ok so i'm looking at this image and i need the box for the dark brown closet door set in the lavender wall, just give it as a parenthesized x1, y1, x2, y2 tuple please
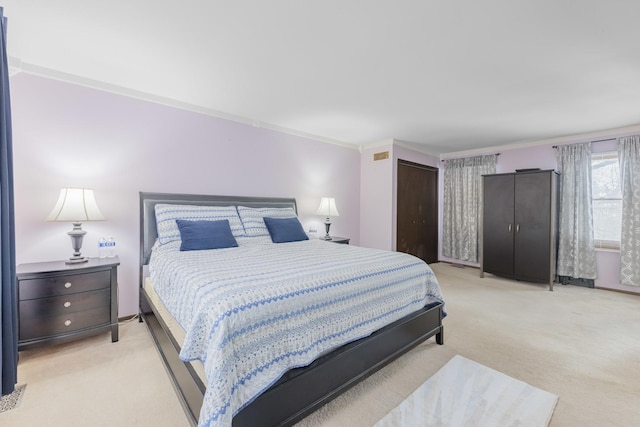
(396, 160, 438, 263)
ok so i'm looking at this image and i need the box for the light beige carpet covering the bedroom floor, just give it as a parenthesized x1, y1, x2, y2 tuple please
(5, 263, 640, 427)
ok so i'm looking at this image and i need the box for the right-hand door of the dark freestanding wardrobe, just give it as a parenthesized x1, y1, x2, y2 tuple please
(514, 171, 553, 282)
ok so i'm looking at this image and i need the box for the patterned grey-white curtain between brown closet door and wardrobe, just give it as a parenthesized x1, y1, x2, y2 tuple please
(442, 154, 497, 262)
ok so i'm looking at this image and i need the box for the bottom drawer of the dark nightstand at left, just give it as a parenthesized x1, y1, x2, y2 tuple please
(20, 306, 110, 341)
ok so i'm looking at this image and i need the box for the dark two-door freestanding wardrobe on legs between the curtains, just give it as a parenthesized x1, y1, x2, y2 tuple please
(481, 170, 558, 290)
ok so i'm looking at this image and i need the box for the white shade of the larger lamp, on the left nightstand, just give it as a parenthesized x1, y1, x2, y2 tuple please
(47, 188, 105, 222)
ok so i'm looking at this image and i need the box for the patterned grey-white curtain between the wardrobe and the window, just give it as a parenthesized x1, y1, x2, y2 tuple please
(557, 142, 596, 279)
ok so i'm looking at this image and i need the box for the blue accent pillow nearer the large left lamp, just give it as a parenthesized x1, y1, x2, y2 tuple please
(176, 219, 238, 251)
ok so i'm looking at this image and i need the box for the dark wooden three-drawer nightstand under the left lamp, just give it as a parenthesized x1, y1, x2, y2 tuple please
(16, 257, 120, 350)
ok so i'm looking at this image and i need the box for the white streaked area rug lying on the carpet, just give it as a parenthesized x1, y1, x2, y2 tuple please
(376, 355, 558, 427)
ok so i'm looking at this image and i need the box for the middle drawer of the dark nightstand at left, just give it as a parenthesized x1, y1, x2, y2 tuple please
(20, 288, 111, 320)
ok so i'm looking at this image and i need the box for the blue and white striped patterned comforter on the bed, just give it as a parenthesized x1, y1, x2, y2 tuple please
(149, 237, 442, 426)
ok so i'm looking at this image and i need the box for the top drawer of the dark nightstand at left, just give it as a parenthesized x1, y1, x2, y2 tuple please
(20, 271, 111, 301)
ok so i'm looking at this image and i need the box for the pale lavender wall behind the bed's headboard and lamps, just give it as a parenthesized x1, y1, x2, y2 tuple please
(11, 74, 360, 316)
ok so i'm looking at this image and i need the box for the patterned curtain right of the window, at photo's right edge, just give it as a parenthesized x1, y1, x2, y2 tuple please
(618, 135, 640, 286)
